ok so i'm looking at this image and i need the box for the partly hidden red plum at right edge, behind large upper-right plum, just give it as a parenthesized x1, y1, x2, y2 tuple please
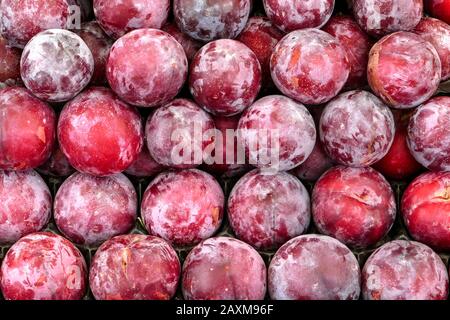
(414, 16, 450, 81)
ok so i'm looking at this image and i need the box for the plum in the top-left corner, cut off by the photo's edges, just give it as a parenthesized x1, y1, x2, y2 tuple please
(0, 0, 70, 48)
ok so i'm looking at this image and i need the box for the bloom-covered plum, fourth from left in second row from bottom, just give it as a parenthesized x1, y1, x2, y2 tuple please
(228, 170, 311, 250)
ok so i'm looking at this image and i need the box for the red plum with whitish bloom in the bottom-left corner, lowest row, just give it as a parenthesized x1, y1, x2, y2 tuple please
(0, 232, 87, 300)
